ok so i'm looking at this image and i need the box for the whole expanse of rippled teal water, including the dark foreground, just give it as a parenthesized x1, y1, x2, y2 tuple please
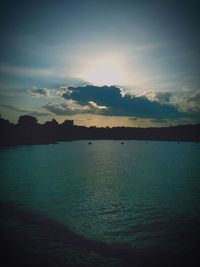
(0, 140, 200, 267)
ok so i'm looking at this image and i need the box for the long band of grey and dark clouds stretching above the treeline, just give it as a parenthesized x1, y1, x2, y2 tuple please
(1, 85, 200, 123)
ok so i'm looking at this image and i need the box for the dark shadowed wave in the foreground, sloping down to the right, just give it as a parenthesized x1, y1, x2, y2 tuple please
(0, 203, 198, 267)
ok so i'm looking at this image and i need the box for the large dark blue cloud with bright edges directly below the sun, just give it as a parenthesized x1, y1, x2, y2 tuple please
(61, 85, 185, 119)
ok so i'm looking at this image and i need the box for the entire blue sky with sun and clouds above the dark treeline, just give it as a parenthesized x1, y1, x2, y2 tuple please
(0, 0, 200, 127)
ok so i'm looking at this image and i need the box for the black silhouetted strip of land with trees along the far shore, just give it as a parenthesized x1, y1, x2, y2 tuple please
(0, 115, 200, 147)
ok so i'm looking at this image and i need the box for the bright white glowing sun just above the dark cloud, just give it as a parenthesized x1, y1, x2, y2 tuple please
(79, 57, 123, 86)
